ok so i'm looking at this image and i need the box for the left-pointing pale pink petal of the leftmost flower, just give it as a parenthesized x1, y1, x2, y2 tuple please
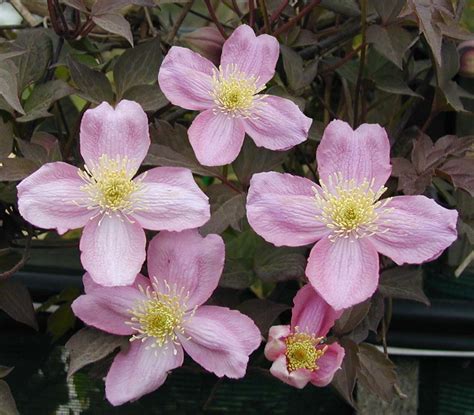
(17, 162, 95, 234)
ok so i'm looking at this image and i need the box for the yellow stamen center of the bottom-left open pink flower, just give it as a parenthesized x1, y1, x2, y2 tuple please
(126, 283, 194, 348)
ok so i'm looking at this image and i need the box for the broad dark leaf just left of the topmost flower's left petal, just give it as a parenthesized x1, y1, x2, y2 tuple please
(114, 38, 163, 100)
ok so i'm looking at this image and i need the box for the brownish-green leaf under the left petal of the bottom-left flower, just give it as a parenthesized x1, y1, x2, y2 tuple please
(65, 327, 128, 379)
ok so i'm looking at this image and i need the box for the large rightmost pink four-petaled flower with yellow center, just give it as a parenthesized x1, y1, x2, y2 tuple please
(247, 120, 458, 309)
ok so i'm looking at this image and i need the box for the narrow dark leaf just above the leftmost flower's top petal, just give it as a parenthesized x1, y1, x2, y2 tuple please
(67, 57, 114, 104)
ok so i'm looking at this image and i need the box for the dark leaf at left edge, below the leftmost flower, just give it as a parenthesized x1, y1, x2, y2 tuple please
(0, 280, 38, 330)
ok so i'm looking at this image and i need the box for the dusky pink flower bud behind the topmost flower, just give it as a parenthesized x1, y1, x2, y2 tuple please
(181, 26, 225, 65)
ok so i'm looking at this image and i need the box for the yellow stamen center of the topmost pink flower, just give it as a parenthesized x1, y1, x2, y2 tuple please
(210, 64, 265, 118)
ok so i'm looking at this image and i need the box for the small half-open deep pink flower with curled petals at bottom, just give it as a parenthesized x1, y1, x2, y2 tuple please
(265, 285, 345, 389)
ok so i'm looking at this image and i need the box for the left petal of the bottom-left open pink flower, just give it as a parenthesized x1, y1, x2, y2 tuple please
(71, 287, 146, 335)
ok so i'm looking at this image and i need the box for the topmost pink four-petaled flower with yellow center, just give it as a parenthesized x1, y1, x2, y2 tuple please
(158, 25, 312, 166)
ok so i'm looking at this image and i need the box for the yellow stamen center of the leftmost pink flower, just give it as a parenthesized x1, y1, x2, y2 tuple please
(79, 154, 141, 213)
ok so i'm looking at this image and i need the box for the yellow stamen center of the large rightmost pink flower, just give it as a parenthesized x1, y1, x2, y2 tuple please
(313, 173, 390, 241)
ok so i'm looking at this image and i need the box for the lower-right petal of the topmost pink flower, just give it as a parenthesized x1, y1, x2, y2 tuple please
(243, 96, 313, 150)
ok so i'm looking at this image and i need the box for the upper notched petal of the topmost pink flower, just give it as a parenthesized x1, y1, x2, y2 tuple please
(221, 25, 280, 86)
